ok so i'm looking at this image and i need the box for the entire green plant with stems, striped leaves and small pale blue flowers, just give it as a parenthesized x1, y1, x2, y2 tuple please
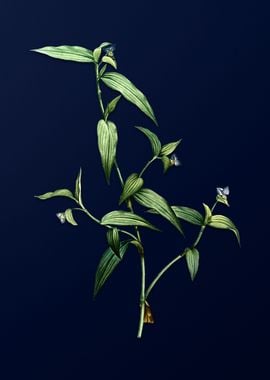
(33, 42, 240, 338)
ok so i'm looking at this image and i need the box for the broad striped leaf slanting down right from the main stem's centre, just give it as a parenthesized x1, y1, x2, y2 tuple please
(134, 189, 183, 233)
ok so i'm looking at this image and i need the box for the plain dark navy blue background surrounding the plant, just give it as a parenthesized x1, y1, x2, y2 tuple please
(0, 0, 269, 380)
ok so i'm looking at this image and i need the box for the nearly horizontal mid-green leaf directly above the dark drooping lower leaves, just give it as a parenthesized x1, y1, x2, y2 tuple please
(100, 210, 159, 231)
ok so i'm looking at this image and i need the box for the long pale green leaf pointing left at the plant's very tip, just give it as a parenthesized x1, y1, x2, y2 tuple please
(31, 45, 94, 63)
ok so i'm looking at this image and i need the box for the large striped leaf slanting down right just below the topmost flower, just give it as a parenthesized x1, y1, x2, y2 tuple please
(101, 72, 157, 125)
